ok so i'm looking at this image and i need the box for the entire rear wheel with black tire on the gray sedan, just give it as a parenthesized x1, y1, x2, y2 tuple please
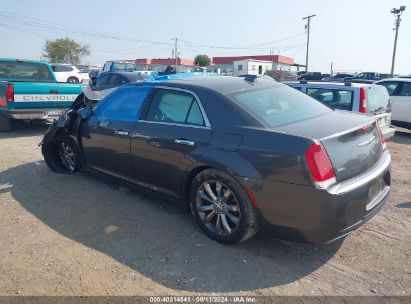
(190, 169, 259, 244)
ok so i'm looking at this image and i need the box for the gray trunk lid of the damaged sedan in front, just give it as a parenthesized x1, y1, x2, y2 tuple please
(275, 111, 383, 182)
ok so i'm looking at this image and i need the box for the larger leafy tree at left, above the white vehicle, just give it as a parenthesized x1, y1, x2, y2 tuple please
(43, 37, 90, 64)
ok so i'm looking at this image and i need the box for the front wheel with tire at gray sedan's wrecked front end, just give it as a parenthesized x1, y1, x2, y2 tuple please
(42, 134, 82, 174)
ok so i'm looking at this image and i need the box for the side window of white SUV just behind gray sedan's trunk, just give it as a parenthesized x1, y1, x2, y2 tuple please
(307, 88, 353, 111)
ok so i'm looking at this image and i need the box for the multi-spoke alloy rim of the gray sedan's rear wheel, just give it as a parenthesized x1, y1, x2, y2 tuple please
(196, 180, 241, 236)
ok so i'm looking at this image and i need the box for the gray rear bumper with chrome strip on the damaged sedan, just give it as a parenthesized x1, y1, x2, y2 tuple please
(248, 151, 391, 244)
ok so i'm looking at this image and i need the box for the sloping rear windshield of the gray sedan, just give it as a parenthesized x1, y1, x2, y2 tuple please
(228, 86, 332, 128)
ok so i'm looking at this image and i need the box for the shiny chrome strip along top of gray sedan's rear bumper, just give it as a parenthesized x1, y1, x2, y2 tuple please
(327, 151, 391, 195)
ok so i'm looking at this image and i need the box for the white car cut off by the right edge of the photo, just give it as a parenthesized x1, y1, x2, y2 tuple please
(376, 78, 411, 130)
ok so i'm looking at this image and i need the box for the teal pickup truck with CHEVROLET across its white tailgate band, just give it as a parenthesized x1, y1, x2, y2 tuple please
(0, 58, 82, 131)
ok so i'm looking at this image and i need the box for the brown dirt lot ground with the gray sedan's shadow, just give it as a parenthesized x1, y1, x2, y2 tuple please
(0, 121, 411, 295)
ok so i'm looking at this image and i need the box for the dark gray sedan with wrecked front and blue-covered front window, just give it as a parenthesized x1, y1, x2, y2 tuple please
(42, 75, 391, 243)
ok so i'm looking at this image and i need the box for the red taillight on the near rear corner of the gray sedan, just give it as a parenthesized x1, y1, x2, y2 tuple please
(305, 142, 336, 189)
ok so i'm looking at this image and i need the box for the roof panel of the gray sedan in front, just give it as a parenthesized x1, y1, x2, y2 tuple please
(135, 74, 282, 94)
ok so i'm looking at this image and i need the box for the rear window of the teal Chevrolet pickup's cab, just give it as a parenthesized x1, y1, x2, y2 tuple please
(0, 61, 54, 81)
